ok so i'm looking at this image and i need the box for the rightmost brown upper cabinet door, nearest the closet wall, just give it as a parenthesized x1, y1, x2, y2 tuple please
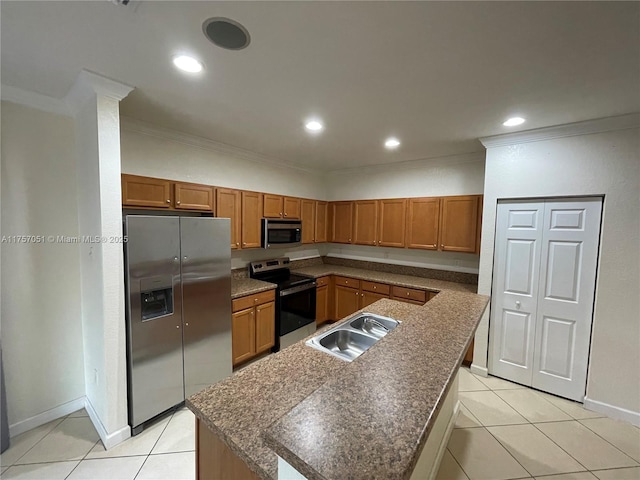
(440, 195, 480, 253)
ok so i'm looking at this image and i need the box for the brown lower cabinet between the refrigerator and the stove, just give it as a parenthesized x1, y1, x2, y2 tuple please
(231, 290, 276, 367)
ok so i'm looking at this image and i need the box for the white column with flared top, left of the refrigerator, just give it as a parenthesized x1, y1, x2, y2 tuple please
(66, 70, 132, 448)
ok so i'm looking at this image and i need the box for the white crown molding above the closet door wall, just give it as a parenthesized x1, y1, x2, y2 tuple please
(479, 113, 640, 148)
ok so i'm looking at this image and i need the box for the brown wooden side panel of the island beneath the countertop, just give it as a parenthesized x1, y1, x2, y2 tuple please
(196, 418, 260, 480)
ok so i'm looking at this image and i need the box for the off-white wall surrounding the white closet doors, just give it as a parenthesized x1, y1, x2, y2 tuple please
(474, 129, 640, 423)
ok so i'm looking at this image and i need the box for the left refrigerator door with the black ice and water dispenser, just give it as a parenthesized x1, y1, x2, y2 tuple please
(125, 216, 184, 430)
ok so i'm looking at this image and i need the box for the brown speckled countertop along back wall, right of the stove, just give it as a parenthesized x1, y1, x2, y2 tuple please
(292, 264, 478, 293)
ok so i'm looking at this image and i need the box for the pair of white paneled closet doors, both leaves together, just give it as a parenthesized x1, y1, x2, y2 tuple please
(489, 198, 602, 401)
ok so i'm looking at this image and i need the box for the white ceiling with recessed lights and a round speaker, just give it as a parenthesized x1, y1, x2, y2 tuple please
(1, 0, 640, 170)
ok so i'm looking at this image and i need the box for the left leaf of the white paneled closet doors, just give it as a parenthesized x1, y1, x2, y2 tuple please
(489, 202, 544, 385)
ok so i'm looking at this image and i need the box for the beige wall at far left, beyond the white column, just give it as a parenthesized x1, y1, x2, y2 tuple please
(1, 102, 85, 430)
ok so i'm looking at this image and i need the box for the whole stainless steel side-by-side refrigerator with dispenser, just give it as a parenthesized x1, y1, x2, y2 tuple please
(124, 215, 231, 435)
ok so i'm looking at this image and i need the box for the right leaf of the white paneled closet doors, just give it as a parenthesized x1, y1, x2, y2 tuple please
(532, 198, 602, 402)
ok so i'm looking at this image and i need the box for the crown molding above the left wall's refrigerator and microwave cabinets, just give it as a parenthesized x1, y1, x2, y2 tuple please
(120, 115, 320, 175)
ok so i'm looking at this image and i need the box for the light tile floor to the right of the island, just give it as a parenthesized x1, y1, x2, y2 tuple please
(437, 368, 640, 480)
